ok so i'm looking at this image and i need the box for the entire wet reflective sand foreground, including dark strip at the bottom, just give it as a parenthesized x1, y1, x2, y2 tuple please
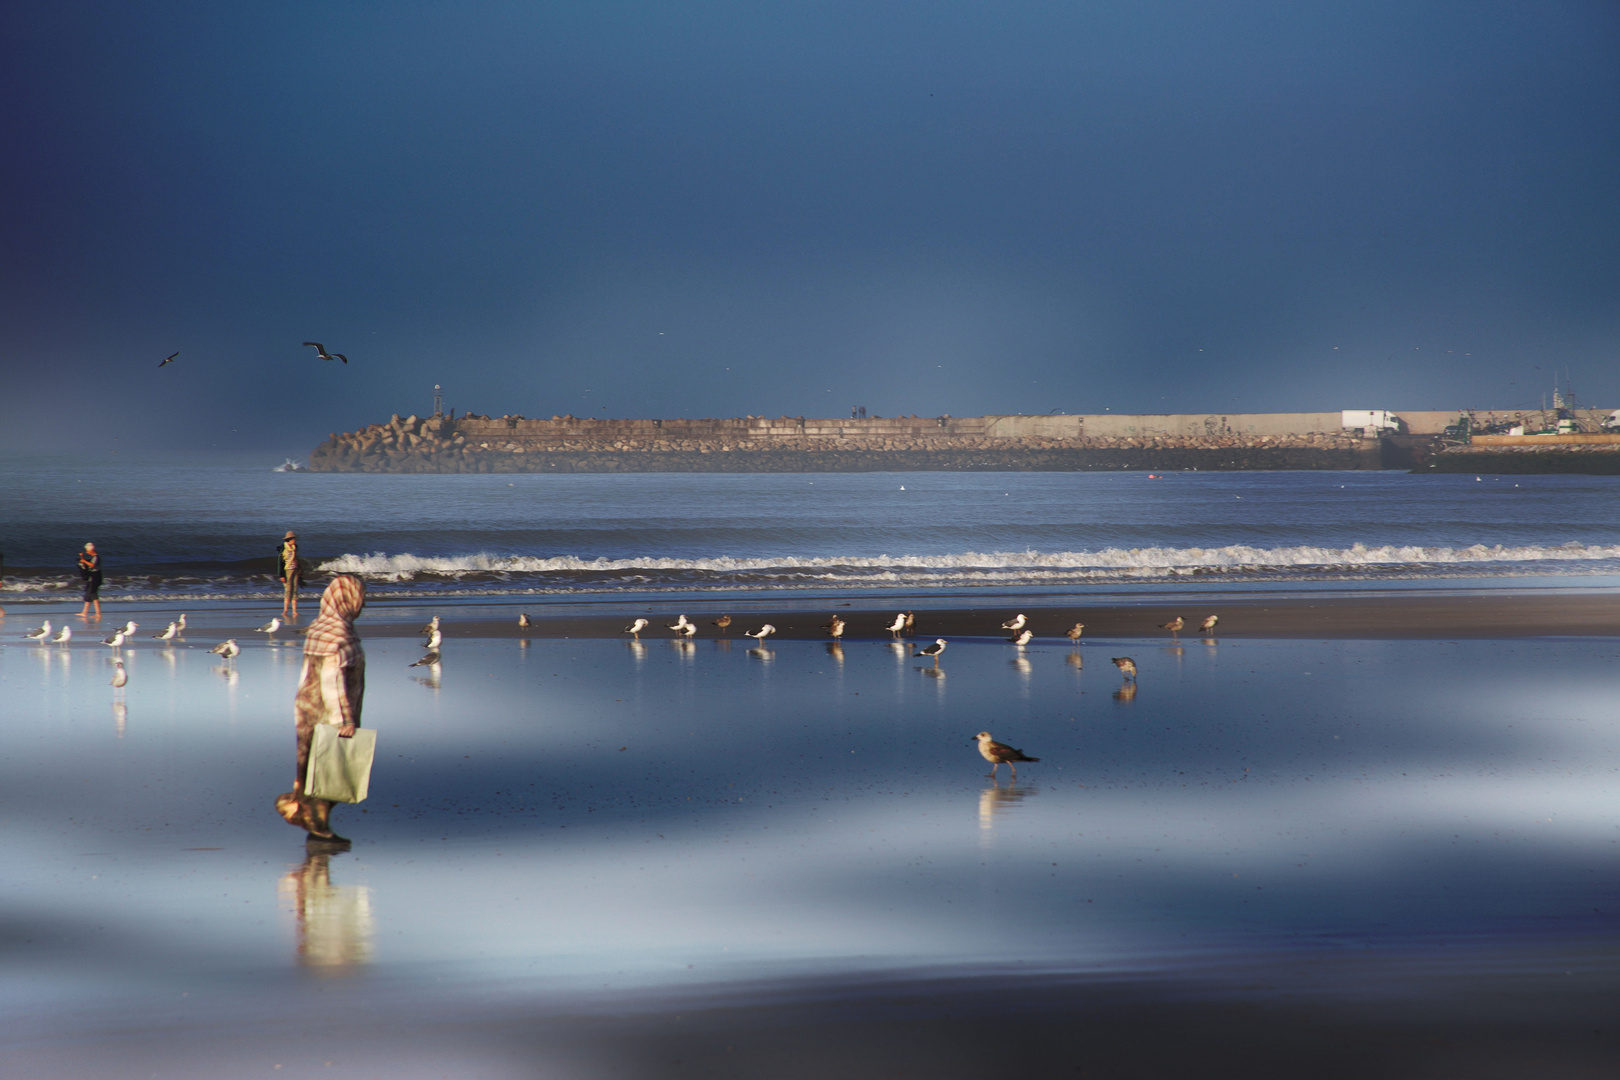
(0, 614, 1620, 1077)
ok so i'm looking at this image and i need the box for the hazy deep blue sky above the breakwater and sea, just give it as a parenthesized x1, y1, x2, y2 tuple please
(0, 0, 1620, 453)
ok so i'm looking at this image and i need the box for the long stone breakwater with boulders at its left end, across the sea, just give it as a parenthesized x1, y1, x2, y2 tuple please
(309, 415, 1411, 473)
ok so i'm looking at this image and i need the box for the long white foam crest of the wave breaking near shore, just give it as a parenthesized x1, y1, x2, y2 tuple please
(319, 544, 1620, 581)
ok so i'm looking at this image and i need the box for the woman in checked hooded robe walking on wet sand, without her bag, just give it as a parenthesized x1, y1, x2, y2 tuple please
(275, 573, 366, 840)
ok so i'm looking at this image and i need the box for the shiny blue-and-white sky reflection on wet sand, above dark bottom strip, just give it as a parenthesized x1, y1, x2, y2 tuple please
(0, 640, 1620, 1016)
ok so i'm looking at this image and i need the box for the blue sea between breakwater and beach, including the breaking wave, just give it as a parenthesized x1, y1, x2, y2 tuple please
(0, 458, 1620, 604)
